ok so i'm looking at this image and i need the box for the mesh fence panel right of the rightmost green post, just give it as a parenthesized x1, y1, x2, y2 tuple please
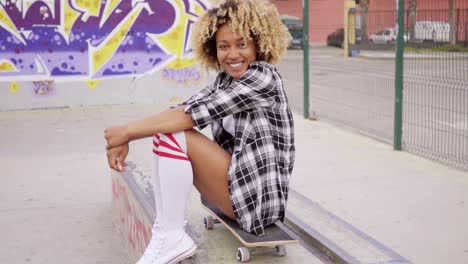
(402, 8, 468, 169)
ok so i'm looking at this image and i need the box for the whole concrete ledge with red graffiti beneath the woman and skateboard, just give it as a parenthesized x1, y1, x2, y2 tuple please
(111, 142, 410, 264)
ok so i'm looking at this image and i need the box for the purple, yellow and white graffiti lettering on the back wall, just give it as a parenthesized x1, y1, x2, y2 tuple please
(0, 0, 212, 81)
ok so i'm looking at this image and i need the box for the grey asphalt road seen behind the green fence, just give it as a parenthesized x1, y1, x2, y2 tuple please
(278, 47, 468, 168)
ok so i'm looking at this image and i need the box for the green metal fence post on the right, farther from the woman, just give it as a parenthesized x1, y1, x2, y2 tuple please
(393, 0, 405, 150)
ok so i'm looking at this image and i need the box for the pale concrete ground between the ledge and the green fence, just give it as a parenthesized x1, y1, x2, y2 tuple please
(292, 116, 468, 264)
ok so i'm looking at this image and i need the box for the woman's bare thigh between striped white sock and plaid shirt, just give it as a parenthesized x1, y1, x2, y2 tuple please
(185, 129, 235, 219)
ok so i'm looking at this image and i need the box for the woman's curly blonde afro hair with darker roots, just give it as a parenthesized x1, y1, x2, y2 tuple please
(192, 0, 291, 70)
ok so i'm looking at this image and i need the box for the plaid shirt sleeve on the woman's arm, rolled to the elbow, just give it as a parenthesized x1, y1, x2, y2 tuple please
(185, 62, 277, 129)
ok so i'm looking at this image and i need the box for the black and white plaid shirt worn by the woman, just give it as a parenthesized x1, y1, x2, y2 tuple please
(183, 62, 295, 236)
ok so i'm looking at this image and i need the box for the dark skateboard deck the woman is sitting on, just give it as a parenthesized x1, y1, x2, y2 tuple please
(201, 196, 298, 247)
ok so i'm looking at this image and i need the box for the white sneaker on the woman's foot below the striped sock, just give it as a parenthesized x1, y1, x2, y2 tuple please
(136, 228, 197, 264)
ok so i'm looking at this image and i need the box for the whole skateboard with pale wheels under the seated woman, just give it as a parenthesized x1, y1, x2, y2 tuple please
(201, 196, 298, 262)
